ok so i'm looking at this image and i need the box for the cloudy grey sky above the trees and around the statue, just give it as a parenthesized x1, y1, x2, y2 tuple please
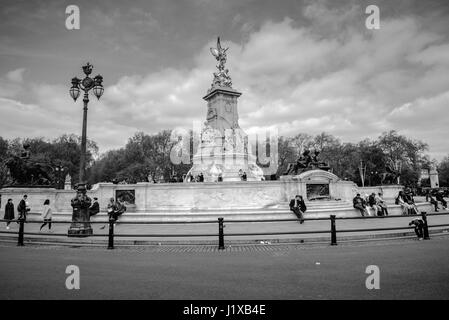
(0, 0, 449, 159)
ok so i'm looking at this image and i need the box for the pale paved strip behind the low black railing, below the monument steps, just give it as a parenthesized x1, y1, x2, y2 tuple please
(0, 214, 449, 243)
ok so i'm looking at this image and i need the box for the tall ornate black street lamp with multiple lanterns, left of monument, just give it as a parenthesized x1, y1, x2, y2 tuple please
(68, 63, 104, 237)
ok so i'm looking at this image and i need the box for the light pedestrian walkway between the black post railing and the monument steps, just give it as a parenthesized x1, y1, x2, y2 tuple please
(0, 214, 449, 246)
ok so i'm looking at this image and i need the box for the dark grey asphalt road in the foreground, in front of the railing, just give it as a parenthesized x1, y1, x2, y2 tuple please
(0, 236, 449, 300)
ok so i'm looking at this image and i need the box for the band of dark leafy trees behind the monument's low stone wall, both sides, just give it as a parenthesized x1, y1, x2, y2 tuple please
(0, 130, 442, 187)
